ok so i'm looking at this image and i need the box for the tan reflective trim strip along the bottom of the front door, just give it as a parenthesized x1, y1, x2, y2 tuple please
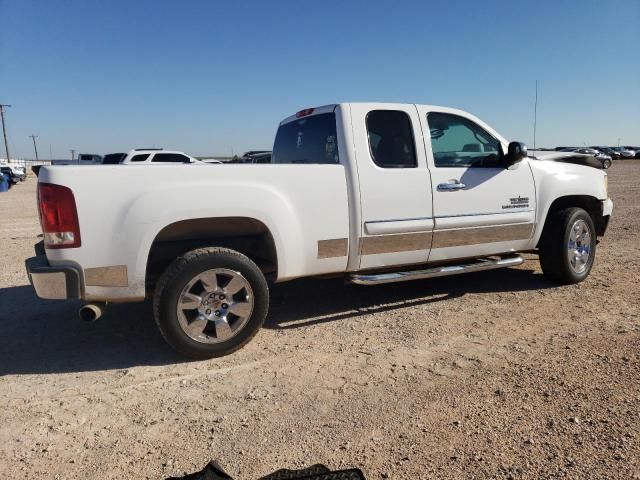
(431, 223, 535, 248)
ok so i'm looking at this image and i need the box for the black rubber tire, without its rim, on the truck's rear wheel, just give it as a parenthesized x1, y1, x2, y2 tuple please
(153, 247, 269, 359)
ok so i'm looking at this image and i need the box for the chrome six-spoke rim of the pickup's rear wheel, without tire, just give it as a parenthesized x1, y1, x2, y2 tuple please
(177, 268, 253, 343)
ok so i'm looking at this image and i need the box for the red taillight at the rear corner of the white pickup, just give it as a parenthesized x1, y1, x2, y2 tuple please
(38, 183, 80, 248)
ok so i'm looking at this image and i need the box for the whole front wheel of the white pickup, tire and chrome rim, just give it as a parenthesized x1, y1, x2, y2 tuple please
(539, 208, 596, 284)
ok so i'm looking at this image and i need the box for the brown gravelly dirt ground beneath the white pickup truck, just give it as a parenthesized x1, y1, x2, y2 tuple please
(0, 161, 640, 479)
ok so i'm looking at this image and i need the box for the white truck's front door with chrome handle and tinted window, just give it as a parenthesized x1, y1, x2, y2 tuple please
(421, 107, 536, 261)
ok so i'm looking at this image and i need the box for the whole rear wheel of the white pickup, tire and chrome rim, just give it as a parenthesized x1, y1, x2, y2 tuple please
(153, 247, 269, 359)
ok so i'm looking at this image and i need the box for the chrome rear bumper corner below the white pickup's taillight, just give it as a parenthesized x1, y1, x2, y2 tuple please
(25, 255, 81, 300)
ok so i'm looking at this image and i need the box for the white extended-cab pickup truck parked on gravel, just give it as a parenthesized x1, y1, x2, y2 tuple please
(27, 103, 613, 358)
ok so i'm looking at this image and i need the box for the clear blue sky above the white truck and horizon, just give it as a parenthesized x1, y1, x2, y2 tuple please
(0, 0, 640, 158)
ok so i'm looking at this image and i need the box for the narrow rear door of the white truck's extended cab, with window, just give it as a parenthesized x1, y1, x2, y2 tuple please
(351, 104, 433, 269)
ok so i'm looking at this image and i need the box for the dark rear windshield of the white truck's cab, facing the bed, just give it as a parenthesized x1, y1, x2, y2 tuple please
(271, 112, 340, 163)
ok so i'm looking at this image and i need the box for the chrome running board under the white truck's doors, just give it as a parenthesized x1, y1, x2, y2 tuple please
(350, 255, 524, 285)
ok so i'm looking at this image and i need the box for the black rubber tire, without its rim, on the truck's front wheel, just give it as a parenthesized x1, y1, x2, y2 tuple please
(539, 207, 596, 284)
